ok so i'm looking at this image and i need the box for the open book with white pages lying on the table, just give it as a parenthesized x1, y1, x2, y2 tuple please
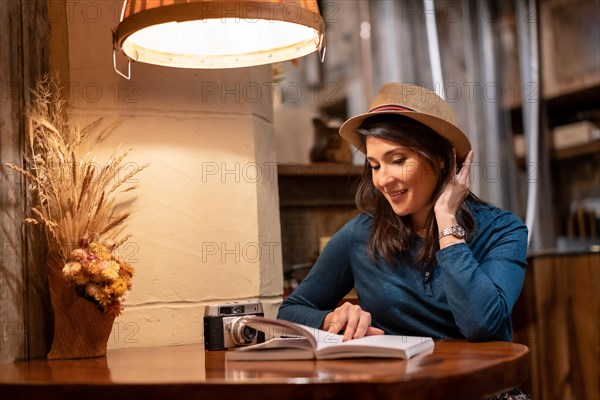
(226, 316, 434, 360)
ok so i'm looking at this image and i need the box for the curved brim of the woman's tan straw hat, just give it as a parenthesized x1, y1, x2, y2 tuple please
(339, 111, 471, 164)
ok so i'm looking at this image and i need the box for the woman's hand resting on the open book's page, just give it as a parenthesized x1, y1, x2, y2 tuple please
(321, 302, 384, 341)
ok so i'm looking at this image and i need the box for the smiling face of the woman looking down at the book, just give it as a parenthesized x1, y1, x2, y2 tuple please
(366, 136, 439, 227)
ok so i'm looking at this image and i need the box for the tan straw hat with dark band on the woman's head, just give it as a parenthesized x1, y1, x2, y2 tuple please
(340, 82, 471, 163)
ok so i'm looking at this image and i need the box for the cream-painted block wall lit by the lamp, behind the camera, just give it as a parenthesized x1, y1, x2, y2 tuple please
(58, 1, 283, 348)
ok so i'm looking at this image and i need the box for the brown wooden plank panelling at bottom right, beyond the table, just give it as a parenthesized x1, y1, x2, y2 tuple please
(514, 253, 600, 400)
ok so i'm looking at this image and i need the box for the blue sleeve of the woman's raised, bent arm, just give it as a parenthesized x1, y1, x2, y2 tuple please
(436, 212, 527, 341)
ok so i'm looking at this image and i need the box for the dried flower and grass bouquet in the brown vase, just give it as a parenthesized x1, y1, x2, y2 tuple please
(5, 76, 147, 316)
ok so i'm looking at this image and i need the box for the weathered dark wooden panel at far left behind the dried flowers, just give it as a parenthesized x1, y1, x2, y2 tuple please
(0, 0, 49, 362)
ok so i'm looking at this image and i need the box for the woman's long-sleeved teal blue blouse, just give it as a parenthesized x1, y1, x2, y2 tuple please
(278, 202, 527, 341)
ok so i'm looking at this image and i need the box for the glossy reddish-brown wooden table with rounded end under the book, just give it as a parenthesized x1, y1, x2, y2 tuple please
(0, 340, 529, 400)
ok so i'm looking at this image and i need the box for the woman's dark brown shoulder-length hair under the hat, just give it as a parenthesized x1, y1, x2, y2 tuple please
(356, 114, 483, 269)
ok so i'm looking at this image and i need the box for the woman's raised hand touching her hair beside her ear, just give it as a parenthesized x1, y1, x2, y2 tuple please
(433, 151, 473, 222)
